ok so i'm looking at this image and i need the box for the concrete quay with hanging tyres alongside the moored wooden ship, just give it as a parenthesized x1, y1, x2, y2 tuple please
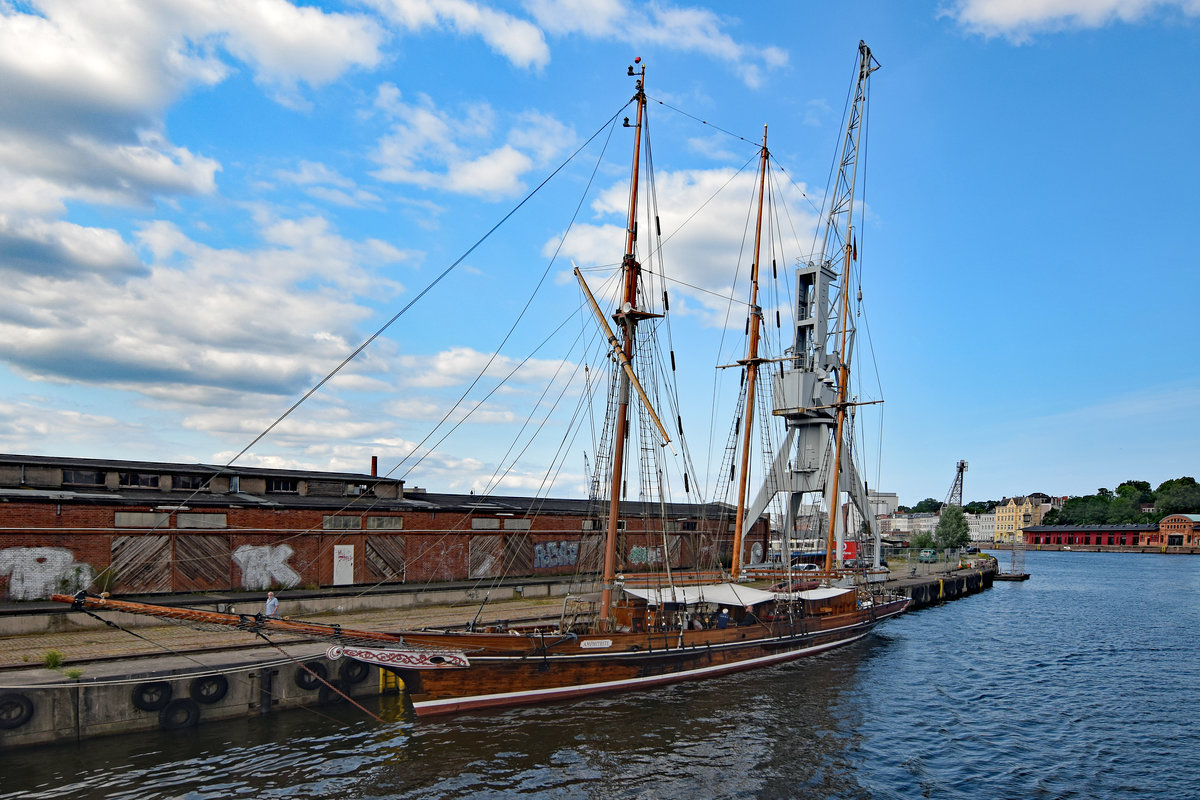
(0, 565, 994, 751)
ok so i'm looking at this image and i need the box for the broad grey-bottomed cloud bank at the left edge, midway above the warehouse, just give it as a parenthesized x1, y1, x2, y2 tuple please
(0, 217, 408, 403)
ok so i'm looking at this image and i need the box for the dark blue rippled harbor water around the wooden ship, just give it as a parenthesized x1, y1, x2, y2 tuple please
(0, 552, 1200, 800)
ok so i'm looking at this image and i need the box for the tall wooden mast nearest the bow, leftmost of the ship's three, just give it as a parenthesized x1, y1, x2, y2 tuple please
(599, 64, 646, 630)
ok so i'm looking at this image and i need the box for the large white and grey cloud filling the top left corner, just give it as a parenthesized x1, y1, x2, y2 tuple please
(0, 0, 385, 213)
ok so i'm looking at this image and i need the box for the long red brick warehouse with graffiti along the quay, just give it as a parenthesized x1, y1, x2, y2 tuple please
(0, 455, 768, 600)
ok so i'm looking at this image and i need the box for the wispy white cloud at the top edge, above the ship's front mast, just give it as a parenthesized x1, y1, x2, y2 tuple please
(526, 0, 787, 88)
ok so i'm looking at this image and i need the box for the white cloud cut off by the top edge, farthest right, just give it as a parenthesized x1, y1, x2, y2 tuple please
(944, 0, 1200, 42)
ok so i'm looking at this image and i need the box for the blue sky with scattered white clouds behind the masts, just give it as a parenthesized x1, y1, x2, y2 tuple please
(0, 0, 1200, 504)
